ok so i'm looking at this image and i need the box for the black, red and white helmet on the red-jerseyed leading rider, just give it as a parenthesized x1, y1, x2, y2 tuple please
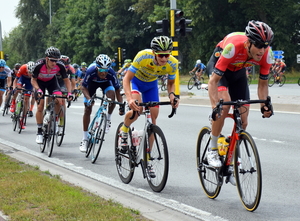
(245, 20, 274, 45)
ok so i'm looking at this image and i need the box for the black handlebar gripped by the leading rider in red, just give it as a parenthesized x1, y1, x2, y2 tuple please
(211, 96, 274, 121)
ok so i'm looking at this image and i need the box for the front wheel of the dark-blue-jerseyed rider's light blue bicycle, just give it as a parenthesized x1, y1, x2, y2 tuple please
(90, 113, 107, 163)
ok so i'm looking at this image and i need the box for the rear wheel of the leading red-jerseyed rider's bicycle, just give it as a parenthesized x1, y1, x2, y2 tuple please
(196, 127, 223, 199)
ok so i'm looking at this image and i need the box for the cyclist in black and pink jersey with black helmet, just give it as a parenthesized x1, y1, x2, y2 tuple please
(31, 46, 73, 144)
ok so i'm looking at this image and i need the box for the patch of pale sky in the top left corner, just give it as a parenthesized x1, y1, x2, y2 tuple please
(0, 0, 19, 37)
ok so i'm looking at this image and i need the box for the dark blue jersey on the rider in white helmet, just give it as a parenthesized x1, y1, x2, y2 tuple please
(82, 63, 120, 89)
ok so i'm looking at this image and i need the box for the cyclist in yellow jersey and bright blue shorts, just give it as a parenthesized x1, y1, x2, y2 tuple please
(120, 36, 179, 177)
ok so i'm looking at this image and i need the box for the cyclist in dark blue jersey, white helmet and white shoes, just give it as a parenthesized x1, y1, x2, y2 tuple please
(79, 54, 124, 152)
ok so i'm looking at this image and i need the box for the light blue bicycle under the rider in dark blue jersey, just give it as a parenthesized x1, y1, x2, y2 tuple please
(85, 94, 124, 163)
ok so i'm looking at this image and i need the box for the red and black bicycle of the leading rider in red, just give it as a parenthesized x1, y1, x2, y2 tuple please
(196, 97, 273, 212)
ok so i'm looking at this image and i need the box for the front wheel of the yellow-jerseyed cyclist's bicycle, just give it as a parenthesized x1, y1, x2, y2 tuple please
(144, 125, 169, 192)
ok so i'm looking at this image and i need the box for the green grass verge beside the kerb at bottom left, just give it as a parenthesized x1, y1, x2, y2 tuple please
(0, 153, 148, 221)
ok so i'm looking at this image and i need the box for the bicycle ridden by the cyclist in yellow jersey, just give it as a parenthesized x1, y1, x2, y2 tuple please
(115, 99, 176, 192)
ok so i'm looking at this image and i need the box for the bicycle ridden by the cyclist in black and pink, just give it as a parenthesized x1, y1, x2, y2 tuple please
(38, 94, 67, 157)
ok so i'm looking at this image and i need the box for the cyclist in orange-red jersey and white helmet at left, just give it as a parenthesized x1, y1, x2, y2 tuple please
(10, 61, 35, 129)
